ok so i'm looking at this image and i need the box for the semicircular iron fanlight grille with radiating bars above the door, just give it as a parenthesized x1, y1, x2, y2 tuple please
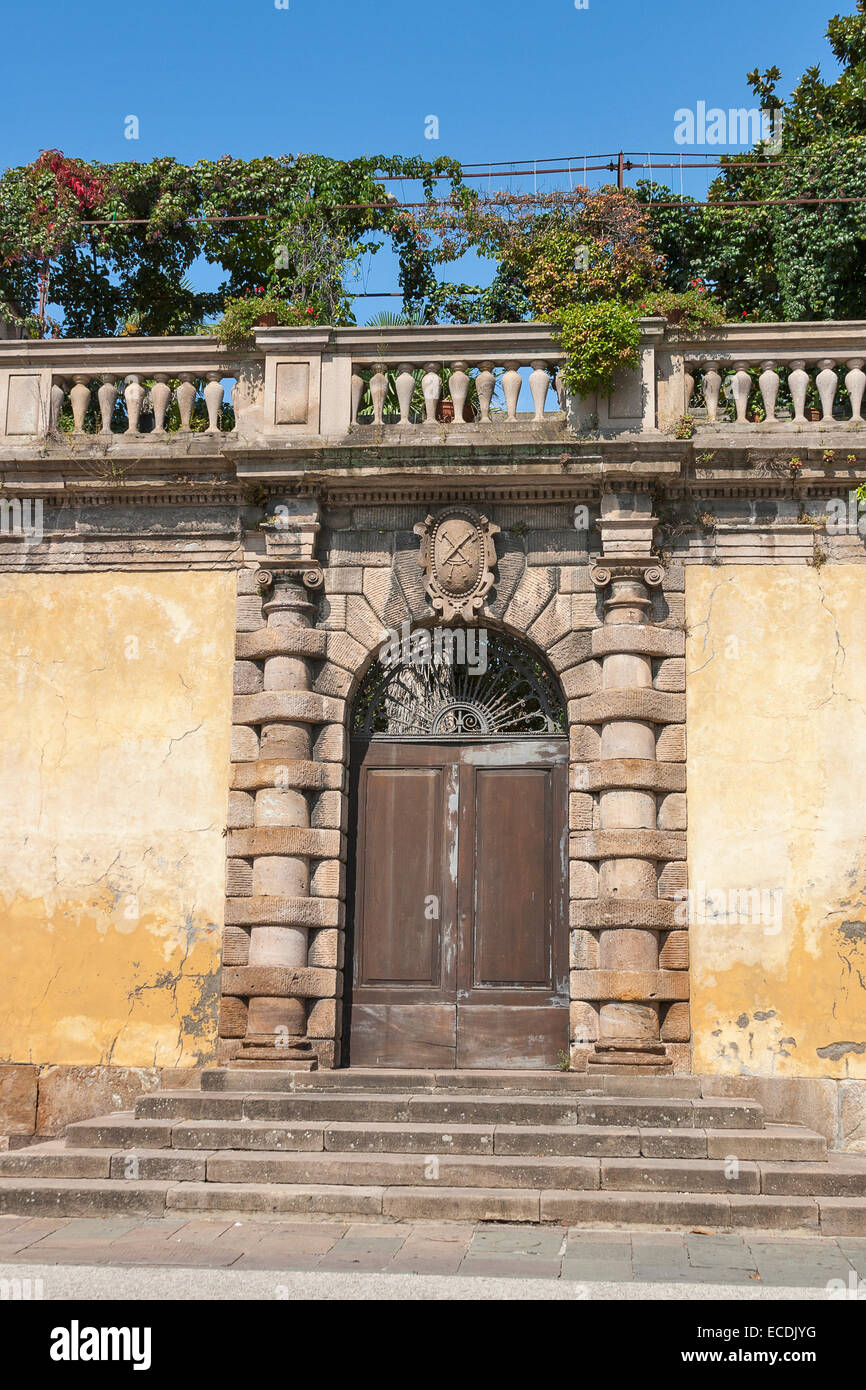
(352, 630, 567, 739)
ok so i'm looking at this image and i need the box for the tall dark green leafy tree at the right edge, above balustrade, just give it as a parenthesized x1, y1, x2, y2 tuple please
(638, 0, 866, 321)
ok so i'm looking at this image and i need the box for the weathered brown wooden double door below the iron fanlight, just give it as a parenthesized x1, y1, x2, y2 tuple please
(346, 737, 569, 1069)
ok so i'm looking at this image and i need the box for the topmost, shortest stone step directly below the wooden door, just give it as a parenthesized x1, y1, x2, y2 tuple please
(202, 1068, 706, 1099)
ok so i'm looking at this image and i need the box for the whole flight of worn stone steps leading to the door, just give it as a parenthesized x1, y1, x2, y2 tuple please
(0, 1069, 866, 1236)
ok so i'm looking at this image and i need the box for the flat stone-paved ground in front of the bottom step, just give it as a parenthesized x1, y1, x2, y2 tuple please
(0, 1216, 866, 1301)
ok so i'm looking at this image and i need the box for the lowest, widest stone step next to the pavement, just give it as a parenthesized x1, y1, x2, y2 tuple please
(0, 1177, 866, 1237)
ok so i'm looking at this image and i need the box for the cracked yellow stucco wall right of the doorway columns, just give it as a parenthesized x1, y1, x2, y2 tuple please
(685, 566, 866, 1077)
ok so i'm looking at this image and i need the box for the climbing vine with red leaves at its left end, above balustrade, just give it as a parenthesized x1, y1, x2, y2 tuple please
(0, 150, 471, 336)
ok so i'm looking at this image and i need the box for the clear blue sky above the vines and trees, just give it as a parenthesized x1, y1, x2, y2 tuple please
(0, 0, 855, 317)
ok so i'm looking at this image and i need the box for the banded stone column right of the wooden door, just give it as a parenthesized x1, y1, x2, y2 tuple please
(578, 495, 688, 1072)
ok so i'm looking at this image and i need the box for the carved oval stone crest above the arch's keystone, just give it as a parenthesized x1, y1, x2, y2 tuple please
(414, 507, 499, 623)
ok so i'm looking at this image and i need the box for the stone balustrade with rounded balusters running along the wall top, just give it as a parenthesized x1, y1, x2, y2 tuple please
(0, 318, 866, 452)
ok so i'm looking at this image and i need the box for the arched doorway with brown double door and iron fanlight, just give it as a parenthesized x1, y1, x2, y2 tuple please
(345, 628, 569, 1069)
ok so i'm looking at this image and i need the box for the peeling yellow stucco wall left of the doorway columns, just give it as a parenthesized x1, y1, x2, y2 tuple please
(0, 573, 235, 1066)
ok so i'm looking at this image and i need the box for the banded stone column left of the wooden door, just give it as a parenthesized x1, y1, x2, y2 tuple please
(222, 499, 341, 1069)
